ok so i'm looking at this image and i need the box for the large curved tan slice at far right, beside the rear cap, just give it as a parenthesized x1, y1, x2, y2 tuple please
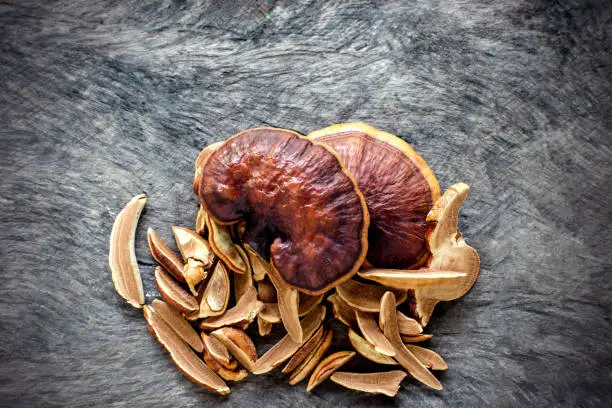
(414, 183, 480, 326)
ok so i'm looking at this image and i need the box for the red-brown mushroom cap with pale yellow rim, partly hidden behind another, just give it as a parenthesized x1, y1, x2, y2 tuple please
(308, 123, 440, 269)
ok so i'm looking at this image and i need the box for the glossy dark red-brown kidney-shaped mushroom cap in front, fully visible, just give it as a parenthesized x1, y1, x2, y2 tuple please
(199, 128, 369, 294)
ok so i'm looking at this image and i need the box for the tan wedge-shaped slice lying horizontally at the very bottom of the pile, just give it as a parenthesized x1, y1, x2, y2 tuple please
(331, 370, 406, 397)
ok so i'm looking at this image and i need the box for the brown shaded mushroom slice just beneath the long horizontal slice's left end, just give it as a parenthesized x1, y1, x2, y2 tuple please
(336, 279, 408, 313)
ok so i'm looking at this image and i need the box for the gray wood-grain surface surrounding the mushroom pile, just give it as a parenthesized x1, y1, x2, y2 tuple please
(0, 0, 612, 407)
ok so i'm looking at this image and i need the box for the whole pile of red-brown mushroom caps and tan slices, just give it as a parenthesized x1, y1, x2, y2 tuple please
(109, 124, 480, 396)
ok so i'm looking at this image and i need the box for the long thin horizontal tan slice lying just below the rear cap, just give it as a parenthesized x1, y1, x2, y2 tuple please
(359, 269, 467, 289)
